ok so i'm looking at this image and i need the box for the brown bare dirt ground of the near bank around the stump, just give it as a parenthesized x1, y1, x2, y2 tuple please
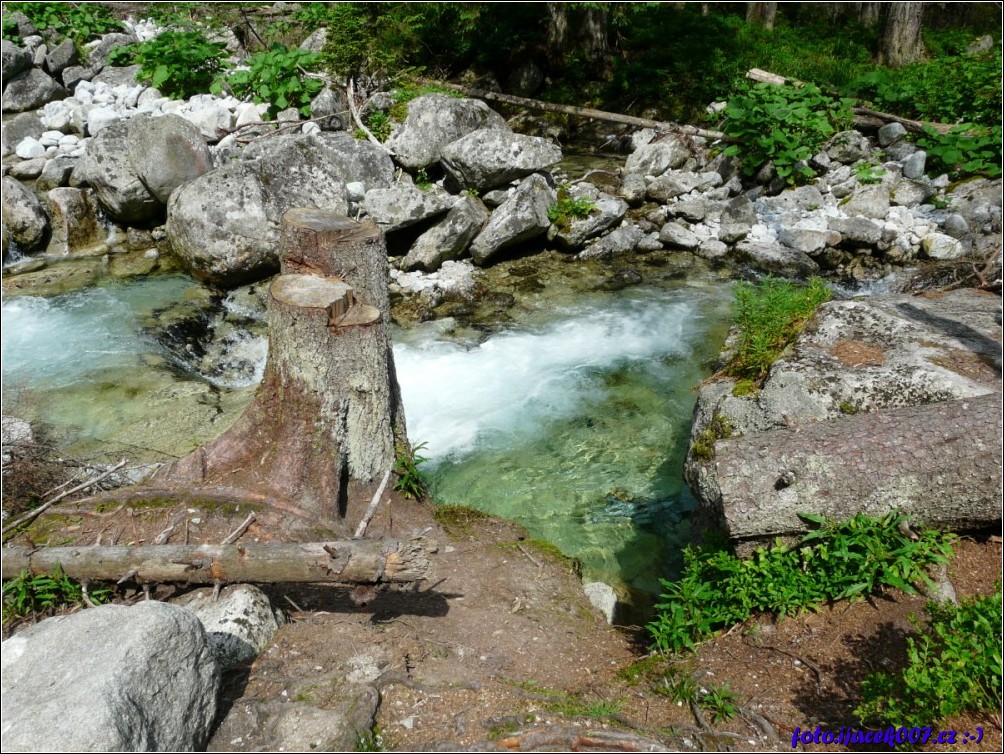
(7, 485, 1002, 751)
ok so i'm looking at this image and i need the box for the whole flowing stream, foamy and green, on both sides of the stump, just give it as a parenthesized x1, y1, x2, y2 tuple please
(2, 269, 729, 614)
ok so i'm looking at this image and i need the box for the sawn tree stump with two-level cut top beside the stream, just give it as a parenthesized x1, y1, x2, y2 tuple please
(155, 210, 407, 531)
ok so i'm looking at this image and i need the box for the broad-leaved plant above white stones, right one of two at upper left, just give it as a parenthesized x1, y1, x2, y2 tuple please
(212, 46, 324, 118)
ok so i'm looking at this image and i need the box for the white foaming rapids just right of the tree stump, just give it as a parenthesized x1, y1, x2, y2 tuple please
(395, 293, 697, 460)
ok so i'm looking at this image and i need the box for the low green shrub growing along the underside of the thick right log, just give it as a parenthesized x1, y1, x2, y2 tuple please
(648, 513, 952, 653)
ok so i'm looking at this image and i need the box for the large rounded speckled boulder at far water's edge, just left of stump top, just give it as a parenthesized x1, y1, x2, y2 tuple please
(167, 162, 279, 288)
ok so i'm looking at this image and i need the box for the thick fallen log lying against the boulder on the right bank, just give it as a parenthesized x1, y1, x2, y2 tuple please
(712, 393, 1002, 540)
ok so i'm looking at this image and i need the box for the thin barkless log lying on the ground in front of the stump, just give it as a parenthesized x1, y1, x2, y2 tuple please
(2, 539, 429, 583)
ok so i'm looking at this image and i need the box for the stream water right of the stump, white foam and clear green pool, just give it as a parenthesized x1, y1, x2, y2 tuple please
(396, 287, 728, 592)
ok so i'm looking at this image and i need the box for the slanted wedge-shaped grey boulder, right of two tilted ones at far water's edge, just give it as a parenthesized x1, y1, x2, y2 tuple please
(471, 175, 557, 265)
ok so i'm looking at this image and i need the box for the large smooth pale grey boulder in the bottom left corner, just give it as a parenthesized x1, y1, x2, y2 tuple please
(0, 601, 220, 751)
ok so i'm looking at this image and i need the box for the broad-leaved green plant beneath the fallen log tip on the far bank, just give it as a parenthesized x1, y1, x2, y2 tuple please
(723, 83, 851, 185)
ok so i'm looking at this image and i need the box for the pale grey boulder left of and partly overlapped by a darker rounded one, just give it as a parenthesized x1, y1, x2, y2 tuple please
(77, 120, 164, 225)
